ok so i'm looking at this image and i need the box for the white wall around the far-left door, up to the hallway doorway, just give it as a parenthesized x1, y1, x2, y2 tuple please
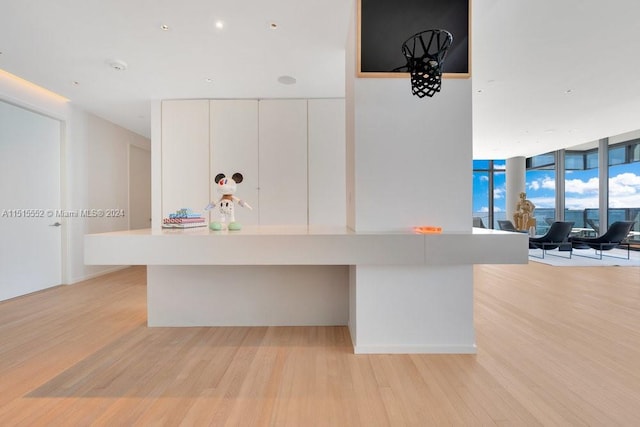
(0, 72, 150, 283)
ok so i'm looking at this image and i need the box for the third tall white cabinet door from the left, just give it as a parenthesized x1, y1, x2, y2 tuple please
(259, 100, 308, 225)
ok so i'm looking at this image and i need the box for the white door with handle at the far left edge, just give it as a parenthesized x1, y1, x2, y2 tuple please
(0, 102, 63, 300)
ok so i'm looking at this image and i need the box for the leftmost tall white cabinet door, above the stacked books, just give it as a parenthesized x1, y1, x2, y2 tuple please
(162, 100, 210, 218)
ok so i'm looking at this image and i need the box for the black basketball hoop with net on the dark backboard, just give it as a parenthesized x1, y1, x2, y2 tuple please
(394, 29, 453, 98)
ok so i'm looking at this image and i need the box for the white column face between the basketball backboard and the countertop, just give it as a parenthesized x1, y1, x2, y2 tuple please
(348, 78, 472, 231)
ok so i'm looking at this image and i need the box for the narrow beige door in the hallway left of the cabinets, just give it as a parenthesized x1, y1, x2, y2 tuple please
(129, 145, 151, 230)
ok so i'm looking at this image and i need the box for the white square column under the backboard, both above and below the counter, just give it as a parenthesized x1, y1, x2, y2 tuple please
(346, 4, 475, 353)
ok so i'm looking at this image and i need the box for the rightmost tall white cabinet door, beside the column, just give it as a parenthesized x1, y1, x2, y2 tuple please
(308, 99, 347, 226)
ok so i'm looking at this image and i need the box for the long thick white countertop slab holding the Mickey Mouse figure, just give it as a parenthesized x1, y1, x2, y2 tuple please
(85, 226, 528, 265)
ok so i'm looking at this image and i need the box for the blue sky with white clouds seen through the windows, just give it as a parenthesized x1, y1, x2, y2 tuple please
(473, 162, 640, 216)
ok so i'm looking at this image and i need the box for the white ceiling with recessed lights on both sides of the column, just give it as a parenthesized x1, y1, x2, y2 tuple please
(0, 0, 640, 159)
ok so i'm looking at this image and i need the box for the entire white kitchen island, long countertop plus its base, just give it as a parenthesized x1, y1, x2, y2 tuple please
(85, 226, 527, 353)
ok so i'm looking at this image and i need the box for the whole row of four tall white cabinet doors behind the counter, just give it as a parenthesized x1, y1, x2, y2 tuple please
(161, 99, 346, 226)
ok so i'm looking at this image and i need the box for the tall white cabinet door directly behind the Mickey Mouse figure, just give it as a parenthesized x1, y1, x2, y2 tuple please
(210, 100, 260, 225)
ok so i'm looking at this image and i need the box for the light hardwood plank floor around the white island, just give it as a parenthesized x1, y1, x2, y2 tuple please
(0, 263, 640, 426)
